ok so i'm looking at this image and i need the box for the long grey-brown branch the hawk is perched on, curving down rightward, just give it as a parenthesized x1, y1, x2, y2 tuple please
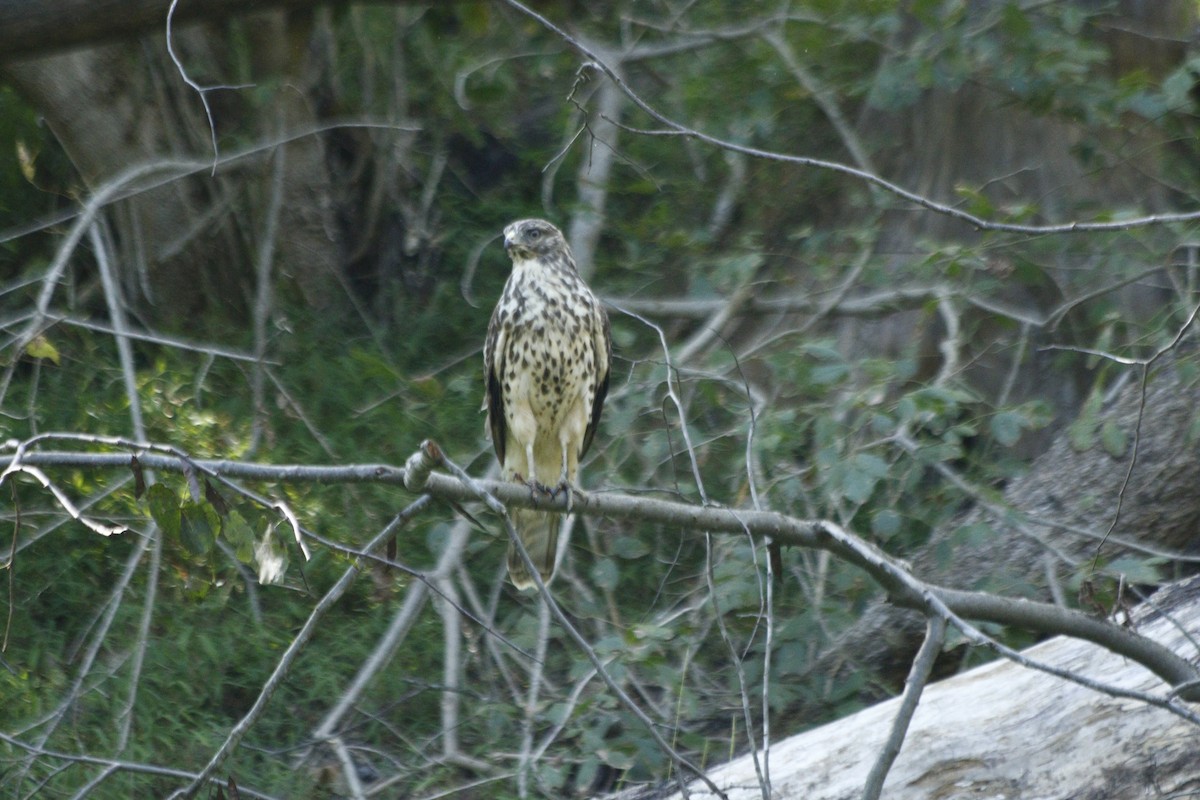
(9, 443, 1200, 700)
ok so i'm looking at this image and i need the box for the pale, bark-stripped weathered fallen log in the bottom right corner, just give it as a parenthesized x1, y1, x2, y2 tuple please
(623, 579, 1200, 800)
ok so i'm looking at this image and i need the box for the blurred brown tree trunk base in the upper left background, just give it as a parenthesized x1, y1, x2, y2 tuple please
(4, 14, 341, 329)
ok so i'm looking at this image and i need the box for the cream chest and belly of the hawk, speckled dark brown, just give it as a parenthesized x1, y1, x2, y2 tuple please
(496, 264, 599, 417)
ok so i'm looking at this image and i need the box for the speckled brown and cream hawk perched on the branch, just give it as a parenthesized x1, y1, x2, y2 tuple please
(484, 219, 612, 589)
